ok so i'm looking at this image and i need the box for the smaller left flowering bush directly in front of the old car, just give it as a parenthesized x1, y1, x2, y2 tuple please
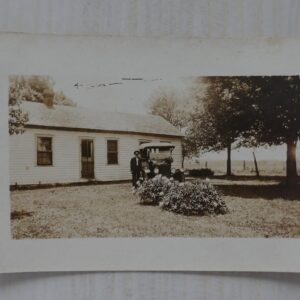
(135, 174, 174, 205)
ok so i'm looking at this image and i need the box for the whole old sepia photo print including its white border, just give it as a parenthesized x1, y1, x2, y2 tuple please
(0, 34, 300, 272)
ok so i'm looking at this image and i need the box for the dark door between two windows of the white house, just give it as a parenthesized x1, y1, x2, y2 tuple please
(81, 140, 95, 179)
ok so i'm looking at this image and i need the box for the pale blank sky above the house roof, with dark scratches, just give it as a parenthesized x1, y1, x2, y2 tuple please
(54, 77, 191, 114)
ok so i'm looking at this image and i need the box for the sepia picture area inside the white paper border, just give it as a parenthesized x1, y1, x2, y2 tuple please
(8, 74, 300, 239)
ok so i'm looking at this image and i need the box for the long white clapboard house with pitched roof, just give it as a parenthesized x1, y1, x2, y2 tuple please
(10, 102, 182, 185)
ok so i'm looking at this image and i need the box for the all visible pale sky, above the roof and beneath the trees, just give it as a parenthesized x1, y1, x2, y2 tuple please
(50, 77, 300, 160)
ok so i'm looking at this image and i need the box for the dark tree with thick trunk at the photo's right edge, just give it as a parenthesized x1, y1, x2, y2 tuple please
(249, 76, 300, 183)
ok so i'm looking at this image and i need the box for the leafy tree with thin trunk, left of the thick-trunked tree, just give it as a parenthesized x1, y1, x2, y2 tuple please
(189, 76, 254, 175)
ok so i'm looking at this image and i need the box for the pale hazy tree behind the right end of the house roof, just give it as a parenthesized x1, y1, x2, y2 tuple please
(148, 89, 198, 167)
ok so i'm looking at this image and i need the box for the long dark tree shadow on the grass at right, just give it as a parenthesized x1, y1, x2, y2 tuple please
(215, 184, 300, 200)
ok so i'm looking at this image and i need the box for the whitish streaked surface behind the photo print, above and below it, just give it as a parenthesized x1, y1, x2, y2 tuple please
(0, 0, 300, 300)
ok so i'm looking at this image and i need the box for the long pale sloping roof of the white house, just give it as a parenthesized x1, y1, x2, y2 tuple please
(21, 101, 183, 136)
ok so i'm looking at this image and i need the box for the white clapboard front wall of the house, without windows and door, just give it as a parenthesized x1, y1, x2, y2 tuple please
(10, 128, 182, 185)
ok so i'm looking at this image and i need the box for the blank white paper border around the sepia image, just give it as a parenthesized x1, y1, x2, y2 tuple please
(0, 34, 300, 272)
